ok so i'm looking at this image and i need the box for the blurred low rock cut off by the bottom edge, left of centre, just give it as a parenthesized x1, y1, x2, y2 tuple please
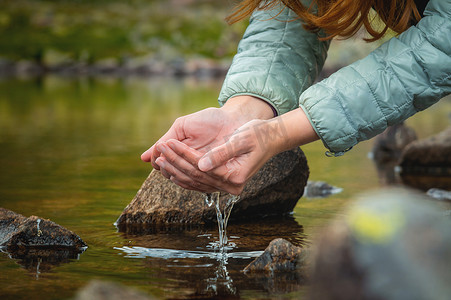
(74, 280, 156, 300)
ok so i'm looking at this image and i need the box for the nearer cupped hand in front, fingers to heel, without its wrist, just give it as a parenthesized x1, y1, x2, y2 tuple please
(157, 120, 276, 195)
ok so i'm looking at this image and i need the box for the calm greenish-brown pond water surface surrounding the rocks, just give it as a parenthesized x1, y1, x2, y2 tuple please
(0, 77, 451, 299)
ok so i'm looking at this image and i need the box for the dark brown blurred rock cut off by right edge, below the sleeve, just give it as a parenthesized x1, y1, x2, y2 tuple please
(400, 127, 451, 190)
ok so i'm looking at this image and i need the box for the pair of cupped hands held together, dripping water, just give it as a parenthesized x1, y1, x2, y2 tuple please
(141, 97, 278, 195)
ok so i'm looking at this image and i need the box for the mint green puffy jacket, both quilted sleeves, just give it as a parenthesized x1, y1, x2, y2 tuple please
(219, 0, 451, 156)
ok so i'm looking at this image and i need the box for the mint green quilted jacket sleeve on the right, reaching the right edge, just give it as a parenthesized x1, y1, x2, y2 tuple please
(299, 0, 451, 156)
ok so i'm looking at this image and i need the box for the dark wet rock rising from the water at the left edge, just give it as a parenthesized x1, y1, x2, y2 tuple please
(0, 208, 86, 252)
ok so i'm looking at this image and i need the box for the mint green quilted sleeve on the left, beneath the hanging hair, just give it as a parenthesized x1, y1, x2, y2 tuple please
(218, 6, 329, 115)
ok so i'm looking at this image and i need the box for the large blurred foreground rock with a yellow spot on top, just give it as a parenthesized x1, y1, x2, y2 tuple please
(310, 190, 451, 300)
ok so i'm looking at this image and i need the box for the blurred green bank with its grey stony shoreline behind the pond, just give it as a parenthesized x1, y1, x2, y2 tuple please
(0, 0, 382, 76)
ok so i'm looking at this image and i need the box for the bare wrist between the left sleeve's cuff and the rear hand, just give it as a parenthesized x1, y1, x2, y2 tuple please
(221, 95, 274, 125)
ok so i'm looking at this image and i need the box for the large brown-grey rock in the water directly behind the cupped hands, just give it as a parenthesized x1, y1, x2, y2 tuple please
(116, 148, 309, 231)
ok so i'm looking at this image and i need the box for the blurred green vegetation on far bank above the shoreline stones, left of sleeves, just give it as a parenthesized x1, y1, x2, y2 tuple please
(0, 0, 246, 65)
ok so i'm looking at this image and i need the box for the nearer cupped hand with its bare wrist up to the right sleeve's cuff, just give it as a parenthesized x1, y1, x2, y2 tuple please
(158, 109, 318, 195)
